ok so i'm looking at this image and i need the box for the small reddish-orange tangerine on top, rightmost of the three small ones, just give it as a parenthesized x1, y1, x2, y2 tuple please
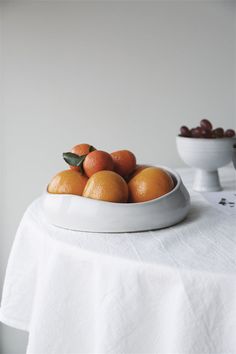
(111, 150, 136, 177)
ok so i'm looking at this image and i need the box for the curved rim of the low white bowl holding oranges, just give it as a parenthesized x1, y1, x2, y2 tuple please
(44, 165, 182, 208)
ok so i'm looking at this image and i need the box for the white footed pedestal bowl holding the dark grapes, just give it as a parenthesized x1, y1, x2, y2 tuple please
(176, 136, 236, 192)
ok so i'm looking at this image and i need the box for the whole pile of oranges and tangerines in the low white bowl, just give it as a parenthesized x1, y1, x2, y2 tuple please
(48, 144, 174, 203)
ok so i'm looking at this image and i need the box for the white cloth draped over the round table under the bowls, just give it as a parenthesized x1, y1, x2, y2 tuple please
(0, 168, 236, 354)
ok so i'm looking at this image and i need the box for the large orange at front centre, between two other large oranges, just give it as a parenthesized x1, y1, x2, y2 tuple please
(83, 171, 128, 203)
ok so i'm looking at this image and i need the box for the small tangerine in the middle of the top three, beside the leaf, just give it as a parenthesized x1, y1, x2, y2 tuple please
(83, 150, 114, 177)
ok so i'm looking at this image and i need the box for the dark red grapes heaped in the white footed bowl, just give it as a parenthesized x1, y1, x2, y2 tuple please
(179, 119, 235, 138)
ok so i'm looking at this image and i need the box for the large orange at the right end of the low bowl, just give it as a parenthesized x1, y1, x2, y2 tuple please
(128, 167, 174, 203)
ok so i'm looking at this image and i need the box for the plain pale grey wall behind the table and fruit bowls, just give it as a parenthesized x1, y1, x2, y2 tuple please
(0, 1, 236, 354)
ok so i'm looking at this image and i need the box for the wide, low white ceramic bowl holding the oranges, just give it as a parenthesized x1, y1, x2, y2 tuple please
(43, 167, 190, 232)
